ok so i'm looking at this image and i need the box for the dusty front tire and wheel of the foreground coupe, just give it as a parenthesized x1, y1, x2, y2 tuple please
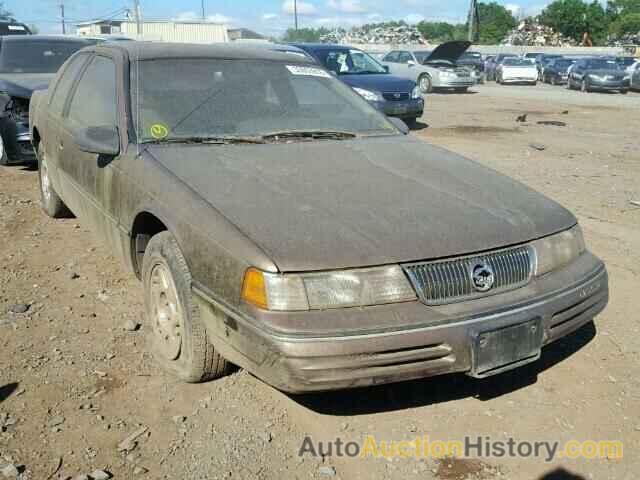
(142, 232, 229, 383)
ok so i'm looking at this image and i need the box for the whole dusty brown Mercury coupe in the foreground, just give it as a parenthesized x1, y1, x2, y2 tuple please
(31, 42, 608, 392)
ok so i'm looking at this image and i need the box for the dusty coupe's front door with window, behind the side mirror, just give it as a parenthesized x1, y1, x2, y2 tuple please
(61, 54, 122, 237)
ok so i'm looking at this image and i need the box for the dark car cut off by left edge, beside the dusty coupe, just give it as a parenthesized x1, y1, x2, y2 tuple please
(0, 35, 95, 165)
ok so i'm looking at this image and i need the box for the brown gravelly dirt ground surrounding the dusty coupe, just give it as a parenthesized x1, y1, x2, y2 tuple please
(0, 84, 640, 480)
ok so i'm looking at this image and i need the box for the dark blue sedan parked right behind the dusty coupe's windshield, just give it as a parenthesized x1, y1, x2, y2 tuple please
(291, 43, 424, 124)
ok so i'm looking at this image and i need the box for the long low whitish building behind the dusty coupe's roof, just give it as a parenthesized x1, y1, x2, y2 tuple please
(76, 20, 229, 43)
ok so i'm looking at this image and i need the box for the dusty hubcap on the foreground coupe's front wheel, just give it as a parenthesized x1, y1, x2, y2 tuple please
(150, 264, 184, 360)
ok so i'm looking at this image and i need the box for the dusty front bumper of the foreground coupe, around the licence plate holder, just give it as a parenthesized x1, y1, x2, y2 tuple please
(194, 253, 609, 393)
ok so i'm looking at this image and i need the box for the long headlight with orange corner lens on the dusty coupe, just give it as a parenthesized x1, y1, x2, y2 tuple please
(242, 265, 416, 311)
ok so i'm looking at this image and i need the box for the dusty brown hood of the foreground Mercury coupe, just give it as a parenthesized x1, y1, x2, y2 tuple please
(149, 136, 576, 271)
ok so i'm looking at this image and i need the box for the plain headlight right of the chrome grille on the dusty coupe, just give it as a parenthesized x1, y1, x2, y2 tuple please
(533, 225, 585, 276)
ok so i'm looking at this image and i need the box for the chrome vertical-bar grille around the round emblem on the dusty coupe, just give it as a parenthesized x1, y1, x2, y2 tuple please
(402, 246, 535, 305)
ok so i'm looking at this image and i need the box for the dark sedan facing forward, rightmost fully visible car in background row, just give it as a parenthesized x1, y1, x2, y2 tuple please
(567, 58, 630, 93)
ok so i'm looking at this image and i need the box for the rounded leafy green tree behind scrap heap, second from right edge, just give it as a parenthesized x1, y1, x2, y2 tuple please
(540, 0, 608, 43)
